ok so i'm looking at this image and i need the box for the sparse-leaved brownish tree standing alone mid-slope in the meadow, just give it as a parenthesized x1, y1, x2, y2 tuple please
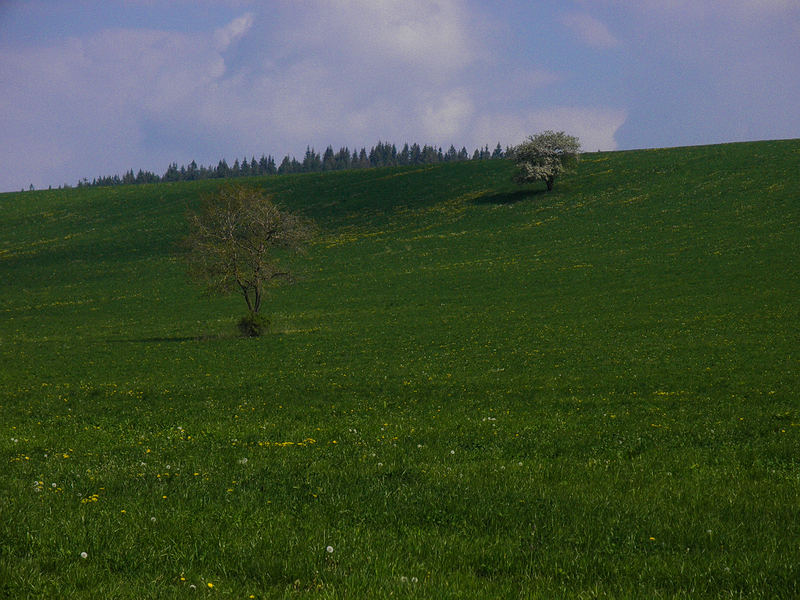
(183, 185, 315, 330)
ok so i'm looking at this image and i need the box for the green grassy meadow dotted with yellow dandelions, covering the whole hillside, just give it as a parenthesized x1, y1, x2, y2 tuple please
(0, 140, 800, 599)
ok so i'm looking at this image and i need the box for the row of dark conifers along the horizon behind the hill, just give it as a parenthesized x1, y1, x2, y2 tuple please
(76, 142, 507, 187)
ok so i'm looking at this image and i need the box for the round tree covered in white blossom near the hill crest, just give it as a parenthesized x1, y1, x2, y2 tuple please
(511, 131, 581, 192)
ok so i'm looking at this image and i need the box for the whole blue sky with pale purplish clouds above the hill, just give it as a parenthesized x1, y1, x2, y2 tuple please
(0, 0, 800, 192)
